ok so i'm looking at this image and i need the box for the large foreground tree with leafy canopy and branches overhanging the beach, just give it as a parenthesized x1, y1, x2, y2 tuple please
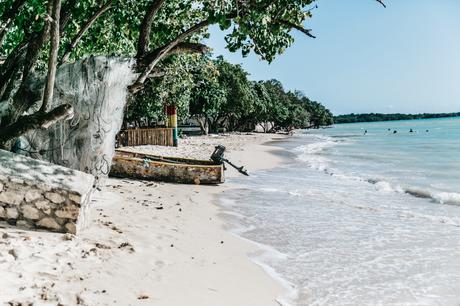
(0, 0, 380, 172)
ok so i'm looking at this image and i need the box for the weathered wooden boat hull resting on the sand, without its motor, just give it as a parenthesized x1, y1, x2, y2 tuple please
(109, 149, 225, 184)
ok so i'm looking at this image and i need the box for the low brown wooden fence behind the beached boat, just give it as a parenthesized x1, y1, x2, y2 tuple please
(118, 128, 174, 146)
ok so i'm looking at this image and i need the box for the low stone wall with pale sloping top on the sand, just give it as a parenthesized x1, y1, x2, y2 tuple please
(0, 150, 94, 234)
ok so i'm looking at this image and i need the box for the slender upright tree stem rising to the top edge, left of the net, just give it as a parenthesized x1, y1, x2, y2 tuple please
(40, 0, 61, 112)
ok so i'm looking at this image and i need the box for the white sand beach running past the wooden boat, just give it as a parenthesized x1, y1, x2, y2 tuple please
(0, 134, 285, 306)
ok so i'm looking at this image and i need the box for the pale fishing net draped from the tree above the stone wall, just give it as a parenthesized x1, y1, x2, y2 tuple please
(20, 56, 136, 178)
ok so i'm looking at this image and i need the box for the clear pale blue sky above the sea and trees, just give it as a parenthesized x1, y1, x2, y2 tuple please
(207, 0, 460, 114)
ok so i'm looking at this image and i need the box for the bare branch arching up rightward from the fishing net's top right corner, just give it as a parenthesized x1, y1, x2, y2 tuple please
(129, 20, 209, 93)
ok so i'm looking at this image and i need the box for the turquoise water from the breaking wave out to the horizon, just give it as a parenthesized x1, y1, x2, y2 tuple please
(300, 118, 460, 204)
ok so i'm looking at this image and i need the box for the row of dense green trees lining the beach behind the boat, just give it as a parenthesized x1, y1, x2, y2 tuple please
(125, 56, 333, 134)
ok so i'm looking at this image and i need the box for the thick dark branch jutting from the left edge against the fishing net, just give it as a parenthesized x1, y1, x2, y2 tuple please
(0, 104, 73, 144)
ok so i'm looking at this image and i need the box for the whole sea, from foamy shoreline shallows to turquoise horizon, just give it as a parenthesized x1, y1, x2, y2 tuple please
(220, 118, 460, 305)
